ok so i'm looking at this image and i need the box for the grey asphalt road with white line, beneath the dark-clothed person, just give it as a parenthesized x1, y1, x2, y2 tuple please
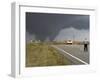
(52, 45, 90, 64)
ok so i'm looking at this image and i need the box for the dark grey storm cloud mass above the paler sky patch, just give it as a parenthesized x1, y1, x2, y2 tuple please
(26, 12, 89, 40)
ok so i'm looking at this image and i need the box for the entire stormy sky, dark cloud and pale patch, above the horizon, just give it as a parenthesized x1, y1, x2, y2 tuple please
(26, 12, 89, 41)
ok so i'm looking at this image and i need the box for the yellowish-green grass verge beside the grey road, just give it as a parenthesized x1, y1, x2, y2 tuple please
(26, 43, 73, 67)
